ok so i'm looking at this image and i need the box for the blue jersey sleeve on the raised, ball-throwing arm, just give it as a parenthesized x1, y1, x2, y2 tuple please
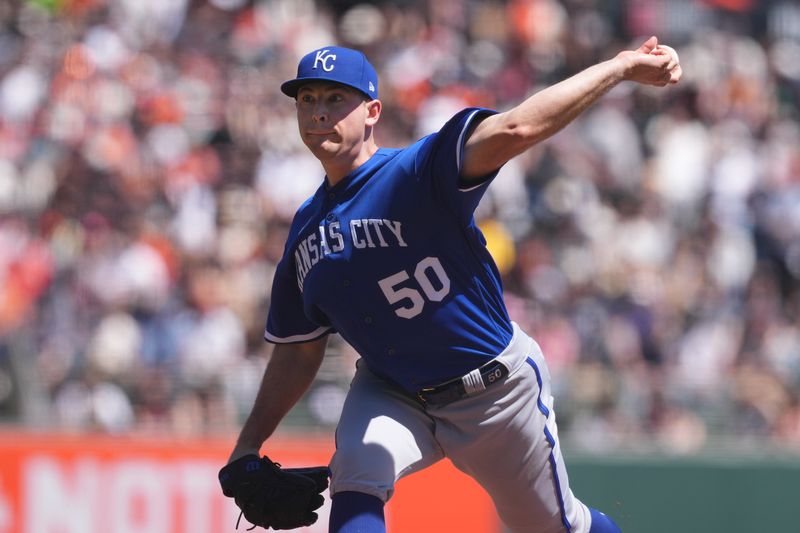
(415, 107, 500, 223)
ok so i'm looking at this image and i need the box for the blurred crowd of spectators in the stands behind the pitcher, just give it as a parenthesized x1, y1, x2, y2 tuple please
(0, 0, 800, 453)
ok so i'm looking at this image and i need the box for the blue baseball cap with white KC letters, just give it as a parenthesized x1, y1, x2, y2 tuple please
(281, 46, 378, 98)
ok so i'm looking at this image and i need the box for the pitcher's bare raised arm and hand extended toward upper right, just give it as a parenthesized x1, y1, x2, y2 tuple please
(460, 37, 682, 182)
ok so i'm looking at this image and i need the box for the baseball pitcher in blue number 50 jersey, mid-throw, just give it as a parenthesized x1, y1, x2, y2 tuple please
(220, 37, 682, 533)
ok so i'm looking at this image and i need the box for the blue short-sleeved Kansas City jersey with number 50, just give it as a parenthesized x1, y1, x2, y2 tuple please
(265, 108, 513, 392)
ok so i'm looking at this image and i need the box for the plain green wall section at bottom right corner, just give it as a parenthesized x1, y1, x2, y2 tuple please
(566, 455, 800, 533)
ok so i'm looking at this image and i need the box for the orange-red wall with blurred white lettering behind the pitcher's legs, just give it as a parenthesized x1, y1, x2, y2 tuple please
(0, 432, 500, 533)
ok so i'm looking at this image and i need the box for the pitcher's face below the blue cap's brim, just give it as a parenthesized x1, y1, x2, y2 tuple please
(296, 82, 377, 161)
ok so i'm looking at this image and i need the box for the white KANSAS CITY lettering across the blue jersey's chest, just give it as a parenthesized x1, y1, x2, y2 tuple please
(294, 218, 408, 292)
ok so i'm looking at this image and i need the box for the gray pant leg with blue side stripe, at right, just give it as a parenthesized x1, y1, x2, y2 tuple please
(430, 336, 591, 533)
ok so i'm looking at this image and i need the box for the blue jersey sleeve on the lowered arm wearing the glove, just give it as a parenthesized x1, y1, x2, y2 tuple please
(264, 256, 333, 344)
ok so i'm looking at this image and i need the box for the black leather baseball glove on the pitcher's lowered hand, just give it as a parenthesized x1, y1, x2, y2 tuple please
(219, 454, 330, 529)
